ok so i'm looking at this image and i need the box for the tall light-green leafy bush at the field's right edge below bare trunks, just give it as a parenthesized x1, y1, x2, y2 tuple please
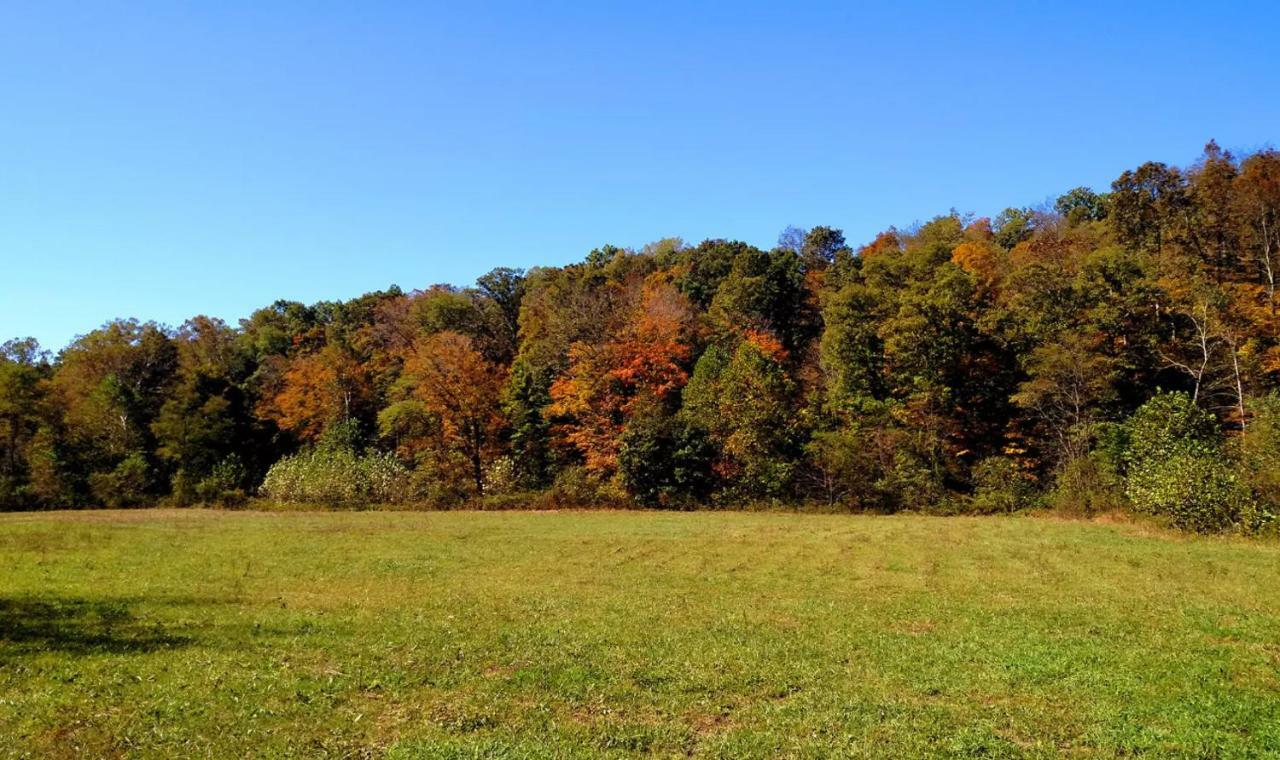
(1125, 393, 1257, 532)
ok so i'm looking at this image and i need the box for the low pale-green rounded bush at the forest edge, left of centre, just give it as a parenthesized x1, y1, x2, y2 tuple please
(261, 448, 413, 504)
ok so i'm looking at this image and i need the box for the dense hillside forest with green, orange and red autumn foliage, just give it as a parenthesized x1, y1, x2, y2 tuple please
(0, 142, 1280, 531)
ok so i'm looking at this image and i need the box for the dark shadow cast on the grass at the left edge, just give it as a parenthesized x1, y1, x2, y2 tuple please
(0, 596, 225, 661)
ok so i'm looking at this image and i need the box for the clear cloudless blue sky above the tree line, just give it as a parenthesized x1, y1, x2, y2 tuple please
(0, 0, 1280, 349)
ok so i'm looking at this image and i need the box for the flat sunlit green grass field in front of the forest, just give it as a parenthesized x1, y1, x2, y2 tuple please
(0, 511, 1280, 757)
